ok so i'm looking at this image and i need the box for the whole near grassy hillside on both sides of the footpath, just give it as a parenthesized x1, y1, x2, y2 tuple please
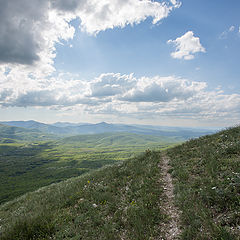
(0, 127, 240, 240)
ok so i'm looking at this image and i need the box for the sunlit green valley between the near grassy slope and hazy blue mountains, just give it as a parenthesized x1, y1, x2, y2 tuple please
(0, 133, 176, 203)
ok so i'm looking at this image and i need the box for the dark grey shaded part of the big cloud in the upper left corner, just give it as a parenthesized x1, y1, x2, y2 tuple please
(0, 0, 46, 64)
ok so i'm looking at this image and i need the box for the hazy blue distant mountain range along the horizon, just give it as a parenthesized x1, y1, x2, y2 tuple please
(0, 120, 218, 140)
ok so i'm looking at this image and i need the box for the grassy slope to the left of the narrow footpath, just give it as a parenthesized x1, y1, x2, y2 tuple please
(0, 152, 167, 240)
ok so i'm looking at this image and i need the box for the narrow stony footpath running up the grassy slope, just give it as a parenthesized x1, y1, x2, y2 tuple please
(159, 153, 181, 240)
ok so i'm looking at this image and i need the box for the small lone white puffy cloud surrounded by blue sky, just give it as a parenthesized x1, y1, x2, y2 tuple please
(167, 31, 206, 60)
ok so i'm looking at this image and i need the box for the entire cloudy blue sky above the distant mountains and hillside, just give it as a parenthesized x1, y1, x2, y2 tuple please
(0, 0, 240, 127)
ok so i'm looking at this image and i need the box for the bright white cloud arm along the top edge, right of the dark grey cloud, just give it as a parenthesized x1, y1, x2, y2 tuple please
(52, 0, 181, 34)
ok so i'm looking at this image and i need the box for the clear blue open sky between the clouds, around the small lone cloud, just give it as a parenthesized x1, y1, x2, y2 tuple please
(55, 0, 240, 90)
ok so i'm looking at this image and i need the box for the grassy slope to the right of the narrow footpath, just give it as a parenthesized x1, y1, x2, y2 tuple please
(168, 127, 240, 240)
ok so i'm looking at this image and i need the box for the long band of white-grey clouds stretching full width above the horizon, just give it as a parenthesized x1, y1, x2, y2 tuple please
(0, 68, 240, 122)
